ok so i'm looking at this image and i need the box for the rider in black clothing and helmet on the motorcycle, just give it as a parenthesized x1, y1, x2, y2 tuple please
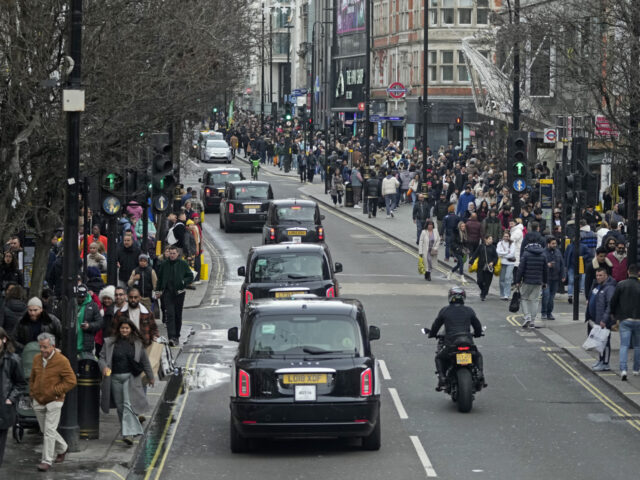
(429, 287, 487, 392)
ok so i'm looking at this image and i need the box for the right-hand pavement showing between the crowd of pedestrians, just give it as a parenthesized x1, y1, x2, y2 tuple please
(238, 156, 640, 406)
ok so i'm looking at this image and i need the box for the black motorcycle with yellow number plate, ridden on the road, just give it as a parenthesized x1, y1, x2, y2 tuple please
(422, 328, 484, 413)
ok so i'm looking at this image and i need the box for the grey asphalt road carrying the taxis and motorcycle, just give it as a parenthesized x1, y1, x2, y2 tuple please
(134, 156, 640, 480)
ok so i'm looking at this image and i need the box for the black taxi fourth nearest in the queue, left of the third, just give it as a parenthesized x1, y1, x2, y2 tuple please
(220, 180, 273, 232)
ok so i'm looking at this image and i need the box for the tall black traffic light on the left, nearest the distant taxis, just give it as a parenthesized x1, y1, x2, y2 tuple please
(151, 133, 176, 213)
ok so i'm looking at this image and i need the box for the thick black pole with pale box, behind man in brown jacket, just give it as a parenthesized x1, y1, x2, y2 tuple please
(58, 0, 82, 452)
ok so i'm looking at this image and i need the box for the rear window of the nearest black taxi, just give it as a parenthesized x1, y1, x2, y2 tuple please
(249, 315, 363, 358)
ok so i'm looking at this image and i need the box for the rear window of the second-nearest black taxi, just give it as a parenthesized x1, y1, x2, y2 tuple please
(251, 252, 330, 283)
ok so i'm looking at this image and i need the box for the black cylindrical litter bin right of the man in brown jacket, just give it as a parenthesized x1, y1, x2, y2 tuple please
(78, 358, 101, 440)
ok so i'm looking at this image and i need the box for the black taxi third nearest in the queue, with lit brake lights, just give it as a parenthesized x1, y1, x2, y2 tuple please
(262, 198, 325, 244)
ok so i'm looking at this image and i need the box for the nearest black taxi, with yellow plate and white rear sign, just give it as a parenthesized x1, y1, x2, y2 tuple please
(227, 298, 382, 453)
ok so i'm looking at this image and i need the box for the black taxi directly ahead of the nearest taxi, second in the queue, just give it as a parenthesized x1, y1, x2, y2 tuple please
(238, 242, 342, 313)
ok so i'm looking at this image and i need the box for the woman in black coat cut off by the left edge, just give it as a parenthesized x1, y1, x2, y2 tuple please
(0, 328, 27, 467)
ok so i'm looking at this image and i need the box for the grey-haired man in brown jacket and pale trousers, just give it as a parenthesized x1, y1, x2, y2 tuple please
(29, 333, 77, 472)
